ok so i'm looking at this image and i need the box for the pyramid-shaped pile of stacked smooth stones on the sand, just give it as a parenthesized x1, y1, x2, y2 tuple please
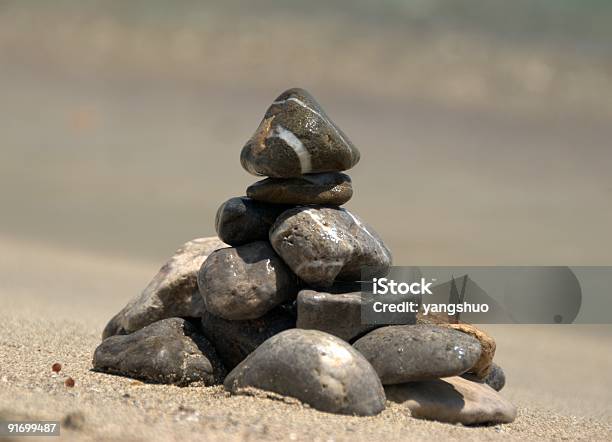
(93, 89, 516, 424)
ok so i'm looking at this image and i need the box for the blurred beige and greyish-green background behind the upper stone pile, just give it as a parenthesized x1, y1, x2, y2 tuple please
(0, 0, 612, 265)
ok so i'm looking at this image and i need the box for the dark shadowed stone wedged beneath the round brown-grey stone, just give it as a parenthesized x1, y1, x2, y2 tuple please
(202, 306, 295, 370)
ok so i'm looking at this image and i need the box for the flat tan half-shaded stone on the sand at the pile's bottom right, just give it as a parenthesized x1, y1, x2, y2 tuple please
(385, 377, 516, 425)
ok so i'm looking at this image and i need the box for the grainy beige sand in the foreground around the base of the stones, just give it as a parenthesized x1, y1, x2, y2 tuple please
(0, 237, 612, 441)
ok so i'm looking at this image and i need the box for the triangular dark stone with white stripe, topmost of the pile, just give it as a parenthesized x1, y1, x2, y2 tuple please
(240, 88, 359, 178)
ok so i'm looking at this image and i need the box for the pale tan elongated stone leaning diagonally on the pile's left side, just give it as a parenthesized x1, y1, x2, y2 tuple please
(102, 237, 227, 339)
